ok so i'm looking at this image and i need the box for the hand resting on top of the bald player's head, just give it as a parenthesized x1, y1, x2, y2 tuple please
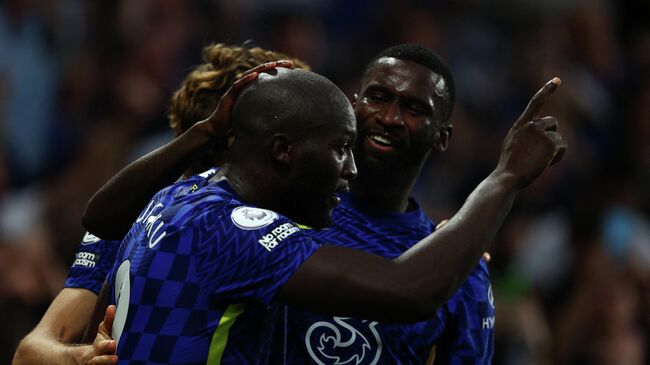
(199, 60, 293, 144)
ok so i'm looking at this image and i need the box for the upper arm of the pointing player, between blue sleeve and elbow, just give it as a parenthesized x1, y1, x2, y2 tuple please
(280, 245, 435, 322)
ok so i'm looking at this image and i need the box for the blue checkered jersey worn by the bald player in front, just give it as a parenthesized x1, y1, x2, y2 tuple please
(109, 175, 319, 364)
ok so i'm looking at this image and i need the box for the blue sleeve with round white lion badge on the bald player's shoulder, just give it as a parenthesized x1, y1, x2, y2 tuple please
(190, 206, 319, 304)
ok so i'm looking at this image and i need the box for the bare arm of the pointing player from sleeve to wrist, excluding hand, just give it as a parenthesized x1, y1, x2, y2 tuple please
(280, 174, 517, 322)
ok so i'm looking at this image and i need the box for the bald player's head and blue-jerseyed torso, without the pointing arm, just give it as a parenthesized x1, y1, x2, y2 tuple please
(108, 69, 356, 364)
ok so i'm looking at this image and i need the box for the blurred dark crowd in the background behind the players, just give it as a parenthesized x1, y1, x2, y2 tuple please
(0, 0, 650, 364)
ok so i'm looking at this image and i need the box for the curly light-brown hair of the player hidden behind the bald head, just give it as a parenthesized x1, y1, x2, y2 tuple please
(168, 43, 310, 137)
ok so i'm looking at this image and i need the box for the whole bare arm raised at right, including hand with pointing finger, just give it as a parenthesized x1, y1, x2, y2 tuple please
(280, 78, 566, 321)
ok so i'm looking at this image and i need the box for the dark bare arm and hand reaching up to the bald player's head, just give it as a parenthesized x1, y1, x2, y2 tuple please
(82, 60, 293, 240)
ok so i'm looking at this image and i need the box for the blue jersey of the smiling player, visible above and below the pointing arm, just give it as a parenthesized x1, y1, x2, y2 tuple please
(288, 194, 494, 365)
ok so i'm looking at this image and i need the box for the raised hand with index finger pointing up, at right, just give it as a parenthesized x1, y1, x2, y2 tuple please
(497, 77, 567, 188)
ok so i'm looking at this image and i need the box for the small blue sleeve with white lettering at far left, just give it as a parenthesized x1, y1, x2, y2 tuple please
(63, 232, 120, 294)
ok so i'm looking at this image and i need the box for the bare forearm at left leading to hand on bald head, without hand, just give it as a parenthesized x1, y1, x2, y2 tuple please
(82, 123, 211, 240)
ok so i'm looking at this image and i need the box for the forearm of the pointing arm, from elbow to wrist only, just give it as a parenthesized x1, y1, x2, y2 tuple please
(395, 172, 519, 308)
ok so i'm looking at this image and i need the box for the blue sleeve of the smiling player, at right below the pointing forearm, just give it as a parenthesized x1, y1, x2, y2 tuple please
(436, 260, 495, 364)
